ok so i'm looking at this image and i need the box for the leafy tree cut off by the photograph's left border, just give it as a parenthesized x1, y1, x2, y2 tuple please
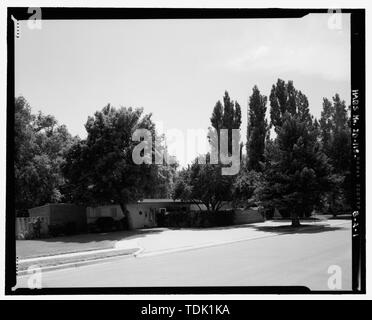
(14, 97, 77, 215)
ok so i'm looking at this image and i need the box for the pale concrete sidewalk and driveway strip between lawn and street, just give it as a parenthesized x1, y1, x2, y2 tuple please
(17, 220, 351, 274)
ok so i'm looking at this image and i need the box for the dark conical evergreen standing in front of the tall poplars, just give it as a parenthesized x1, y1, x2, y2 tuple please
(260, 113, 335, 226)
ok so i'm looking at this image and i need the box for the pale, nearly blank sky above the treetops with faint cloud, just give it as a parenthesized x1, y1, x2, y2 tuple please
(15, 14, 350, 164)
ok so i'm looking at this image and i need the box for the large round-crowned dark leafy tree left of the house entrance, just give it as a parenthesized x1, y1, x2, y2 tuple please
(64, 105, 169, 221)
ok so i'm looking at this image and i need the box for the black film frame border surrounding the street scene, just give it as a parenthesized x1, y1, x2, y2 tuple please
(5, 7, 366, 295)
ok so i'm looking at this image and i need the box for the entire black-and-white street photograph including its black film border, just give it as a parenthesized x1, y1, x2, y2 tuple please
(2, 3, 365, 298)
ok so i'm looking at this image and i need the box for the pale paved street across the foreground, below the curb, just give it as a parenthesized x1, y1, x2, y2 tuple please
(18, 221, 351, 290)
